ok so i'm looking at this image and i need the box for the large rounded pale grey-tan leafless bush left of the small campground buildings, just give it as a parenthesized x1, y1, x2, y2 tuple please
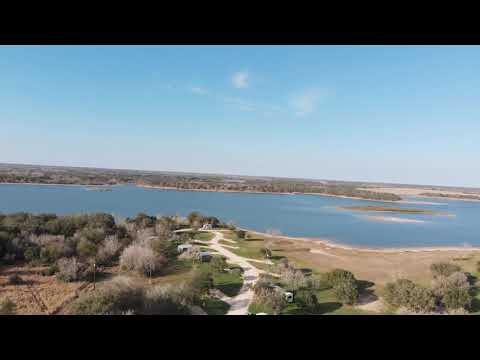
(120, 245, 166, 275)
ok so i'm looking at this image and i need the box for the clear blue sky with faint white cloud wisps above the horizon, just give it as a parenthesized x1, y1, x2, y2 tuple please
(0, 46, 480, 186)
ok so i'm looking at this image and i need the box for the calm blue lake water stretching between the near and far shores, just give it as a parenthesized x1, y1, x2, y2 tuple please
(0, 184, 480, 247)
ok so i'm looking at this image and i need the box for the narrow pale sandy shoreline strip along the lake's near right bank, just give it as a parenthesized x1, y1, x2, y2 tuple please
(241, 228, 480, 254)
